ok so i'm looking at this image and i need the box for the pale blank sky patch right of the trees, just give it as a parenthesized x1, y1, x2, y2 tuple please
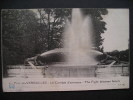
(102, 9, 129, 52)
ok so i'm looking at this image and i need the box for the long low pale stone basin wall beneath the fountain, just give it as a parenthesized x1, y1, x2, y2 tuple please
(8, 64, 129, 78)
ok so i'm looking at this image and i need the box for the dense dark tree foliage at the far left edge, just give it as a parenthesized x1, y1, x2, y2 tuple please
(2, 10, 38, 64)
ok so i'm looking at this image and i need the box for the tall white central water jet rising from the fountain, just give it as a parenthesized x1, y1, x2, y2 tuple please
(64, 8, 96, 66)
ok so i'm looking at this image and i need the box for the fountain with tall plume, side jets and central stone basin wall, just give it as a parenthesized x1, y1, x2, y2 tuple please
(22, 8, 120, 77)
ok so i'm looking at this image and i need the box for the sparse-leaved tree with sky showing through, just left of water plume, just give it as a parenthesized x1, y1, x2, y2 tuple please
(38, 8, 71, 51)
